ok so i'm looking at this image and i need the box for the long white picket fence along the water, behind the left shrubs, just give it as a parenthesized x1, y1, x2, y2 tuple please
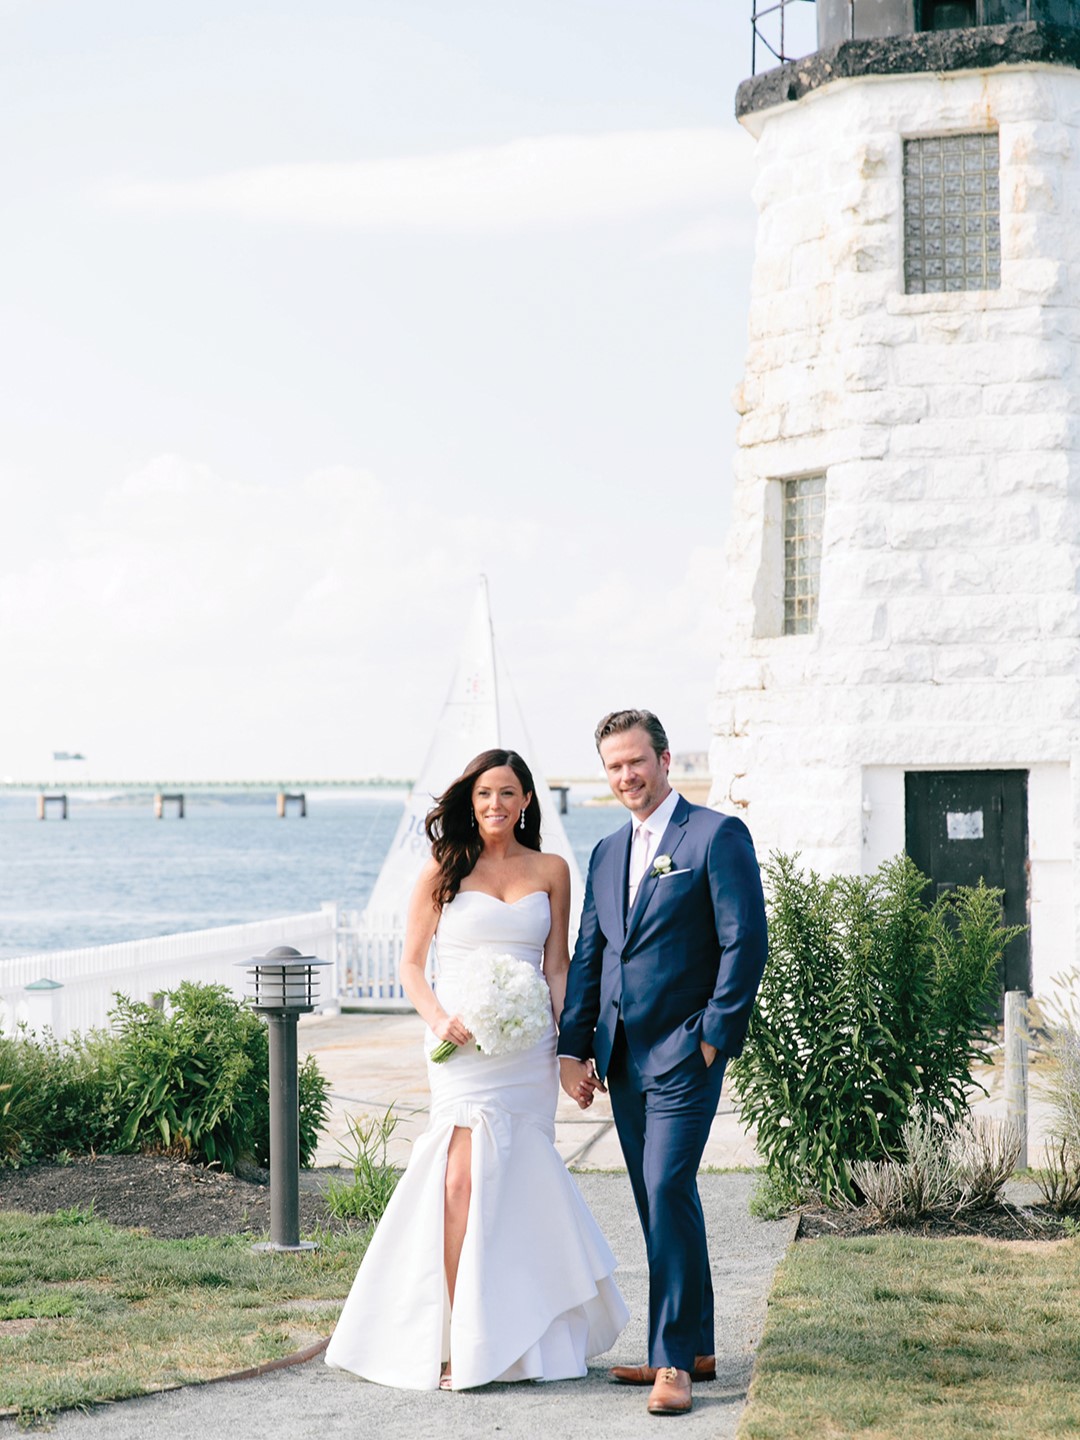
(0, 903, 338, 1040)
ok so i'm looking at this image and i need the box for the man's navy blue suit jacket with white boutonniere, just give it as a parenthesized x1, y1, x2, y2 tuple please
(559, 796, 766, 1076)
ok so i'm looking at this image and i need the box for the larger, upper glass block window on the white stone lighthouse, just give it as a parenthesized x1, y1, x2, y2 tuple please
(904, 131, 1001, 295)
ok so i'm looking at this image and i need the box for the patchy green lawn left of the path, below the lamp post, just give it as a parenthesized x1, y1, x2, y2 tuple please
(0, 1210, 367, 1420)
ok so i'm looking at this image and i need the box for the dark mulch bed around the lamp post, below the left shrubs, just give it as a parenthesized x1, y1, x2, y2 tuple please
(0, 1155, 333, 1240)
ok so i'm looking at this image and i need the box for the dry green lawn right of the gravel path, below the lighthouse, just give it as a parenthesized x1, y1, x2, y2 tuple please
(739, 1234, 1080, 1440)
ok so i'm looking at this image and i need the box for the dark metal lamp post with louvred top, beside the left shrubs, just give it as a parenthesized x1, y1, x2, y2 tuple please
(238, 945, 330, 1251)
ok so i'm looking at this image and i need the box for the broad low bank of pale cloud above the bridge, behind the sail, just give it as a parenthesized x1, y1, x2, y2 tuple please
(0, 455, 721, 779)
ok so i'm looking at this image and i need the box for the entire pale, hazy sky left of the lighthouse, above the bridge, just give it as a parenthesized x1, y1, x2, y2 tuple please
(0, 0, 817, 780)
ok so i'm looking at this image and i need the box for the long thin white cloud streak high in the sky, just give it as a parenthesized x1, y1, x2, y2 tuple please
(105, 130, 753, 235)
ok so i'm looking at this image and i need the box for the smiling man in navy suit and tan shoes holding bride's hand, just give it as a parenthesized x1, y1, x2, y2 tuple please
(559, 710, 766, 1416)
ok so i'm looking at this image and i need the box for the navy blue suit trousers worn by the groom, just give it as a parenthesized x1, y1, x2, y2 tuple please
(606, 1024, 724, 1371)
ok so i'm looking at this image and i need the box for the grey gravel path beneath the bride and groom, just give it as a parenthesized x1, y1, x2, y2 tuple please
(0, 1172, 795, 1440)
